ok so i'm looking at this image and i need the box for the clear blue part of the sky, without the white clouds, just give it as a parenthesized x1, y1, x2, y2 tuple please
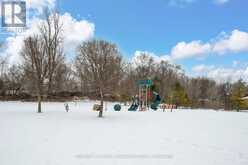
(59, 0, 248, 69)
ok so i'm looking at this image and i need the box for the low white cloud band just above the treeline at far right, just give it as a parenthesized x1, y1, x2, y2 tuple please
(192, 65, 248, 83)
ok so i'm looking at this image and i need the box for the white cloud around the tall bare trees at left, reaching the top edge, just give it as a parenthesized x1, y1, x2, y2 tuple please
(0, 0, 95, 64)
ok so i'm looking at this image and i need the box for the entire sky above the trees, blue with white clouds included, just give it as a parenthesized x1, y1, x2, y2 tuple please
(0, 0, 248, 82)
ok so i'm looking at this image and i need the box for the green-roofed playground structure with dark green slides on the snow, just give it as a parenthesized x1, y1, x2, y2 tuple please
(128, 79, 161, 111)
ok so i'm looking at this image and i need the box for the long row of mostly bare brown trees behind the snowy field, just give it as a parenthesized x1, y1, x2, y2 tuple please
(0, 13, 248, 110)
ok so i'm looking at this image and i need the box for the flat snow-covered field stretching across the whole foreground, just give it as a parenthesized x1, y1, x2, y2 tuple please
(0, 101, 248, 165)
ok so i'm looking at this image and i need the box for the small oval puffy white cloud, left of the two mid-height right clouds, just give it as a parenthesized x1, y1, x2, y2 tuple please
(170, 41, 211, 60)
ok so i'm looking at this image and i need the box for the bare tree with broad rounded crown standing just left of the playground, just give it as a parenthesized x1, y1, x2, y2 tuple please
(76, 40, 122, 117)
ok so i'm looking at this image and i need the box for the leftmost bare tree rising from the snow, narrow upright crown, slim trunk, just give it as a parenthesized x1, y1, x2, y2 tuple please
(21, 36, 49, 113)
